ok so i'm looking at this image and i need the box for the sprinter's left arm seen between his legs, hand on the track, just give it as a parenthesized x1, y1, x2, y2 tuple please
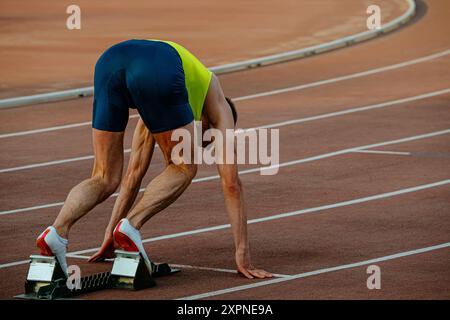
(89, 119, 155, 261)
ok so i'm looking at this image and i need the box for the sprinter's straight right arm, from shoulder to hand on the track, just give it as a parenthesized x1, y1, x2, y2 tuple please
(205, 76, 272, 279)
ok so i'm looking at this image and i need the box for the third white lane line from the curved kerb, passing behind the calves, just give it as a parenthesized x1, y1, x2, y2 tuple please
(0, 129, 450, 215)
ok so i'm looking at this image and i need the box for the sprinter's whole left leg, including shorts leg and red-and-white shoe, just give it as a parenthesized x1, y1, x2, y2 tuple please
(36, 42, 131, 273)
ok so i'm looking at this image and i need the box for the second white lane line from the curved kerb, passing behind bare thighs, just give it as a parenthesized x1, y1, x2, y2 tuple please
(0, 88, 450, 173)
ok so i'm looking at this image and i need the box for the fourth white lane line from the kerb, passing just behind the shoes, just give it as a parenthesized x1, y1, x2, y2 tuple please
(0, 179, 450, 269)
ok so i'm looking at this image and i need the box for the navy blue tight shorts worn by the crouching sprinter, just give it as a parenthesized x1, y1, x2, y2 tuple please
(92, 40, 194, 133)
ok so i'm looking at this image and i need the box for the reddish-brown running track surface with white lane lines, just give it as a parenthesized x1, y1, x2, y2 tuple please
(0, 0, 450, 299)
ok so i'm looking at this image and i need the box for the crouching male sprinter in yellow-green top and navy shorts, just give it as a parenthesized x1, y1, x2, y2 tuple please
(37, 40, 272, 279)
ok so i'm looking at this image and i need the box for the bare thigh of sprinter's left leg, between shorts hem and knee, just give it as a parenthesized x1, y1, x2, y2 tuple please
(92, 128, 124, 179)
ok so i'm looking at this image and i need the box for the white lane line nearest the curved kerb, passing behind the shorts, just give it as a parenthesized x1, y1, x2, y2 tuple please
(0, 49, 450, 138)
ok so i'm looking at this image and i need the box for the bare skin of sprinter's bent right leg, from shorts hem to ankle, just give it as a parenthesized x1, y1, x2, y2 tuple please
(127, 122, 197, 230)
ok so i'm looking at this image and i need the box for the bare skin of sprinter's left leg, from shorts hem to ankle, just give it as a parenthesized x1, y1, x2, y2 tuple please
(53, 129, 124, 238)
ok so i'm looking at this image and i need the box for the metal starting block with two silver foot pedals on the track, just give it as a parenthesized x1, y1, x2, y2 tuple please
(15, 250, 180, 300)
